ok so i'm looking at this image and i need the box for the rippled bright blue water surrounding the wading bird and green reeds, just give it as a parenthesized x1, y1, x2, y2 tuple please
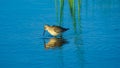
(0, 0, 120, 68)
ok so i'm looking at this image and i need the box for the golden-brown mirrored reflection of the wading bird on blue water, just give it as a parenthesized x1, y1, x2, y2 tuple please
(44, 37, 68, 49)
